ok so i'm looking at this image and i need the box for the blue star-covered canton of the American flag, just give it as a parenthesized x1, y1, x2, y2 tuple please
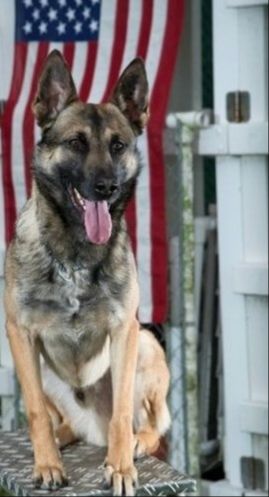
(16, 0, 101, 42)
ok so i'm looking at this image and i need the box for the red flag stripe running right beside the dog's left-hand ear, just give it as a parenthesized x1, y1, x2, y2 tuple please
(22, 42, 49, 196)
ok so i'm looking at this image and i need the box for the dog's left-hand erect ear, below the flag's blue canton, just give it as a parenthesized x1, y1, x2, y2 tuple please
(33, 50, 78, 127)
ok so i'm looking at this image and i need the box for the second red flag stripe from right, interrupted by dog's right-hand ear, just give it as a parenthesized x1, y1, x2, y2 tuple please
(126, 0, 153, 254)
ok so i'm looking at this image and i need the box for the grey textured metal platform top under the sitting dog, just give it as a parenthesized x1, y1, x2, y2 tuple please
(0, 431, 195, 497)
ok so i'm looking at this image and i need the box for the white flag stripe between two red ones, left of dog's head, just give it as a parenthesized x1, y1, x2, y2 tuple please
(11, 42, 39, 214)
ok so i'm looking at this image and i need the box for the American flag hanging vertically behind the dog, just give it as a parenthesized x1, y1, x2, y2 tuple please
(0, 0, 184, 323)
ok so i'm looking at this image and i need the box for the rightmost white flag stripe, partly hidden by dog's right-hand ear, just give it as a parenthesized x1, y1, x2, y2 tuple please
(135, 0, 168, 323)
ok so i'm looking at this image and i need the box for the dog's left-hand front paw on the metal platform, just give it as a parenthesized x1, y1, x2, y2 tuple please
(33, 465, 68, 490)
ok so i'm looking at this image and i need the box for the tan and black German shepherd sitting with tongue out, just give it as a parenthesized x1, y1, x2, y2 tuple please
(5, 51, 170, 495)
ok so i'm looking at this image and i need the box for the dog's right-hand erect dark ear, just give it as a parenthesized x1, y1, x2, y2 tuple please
(111, 58, 149, 134)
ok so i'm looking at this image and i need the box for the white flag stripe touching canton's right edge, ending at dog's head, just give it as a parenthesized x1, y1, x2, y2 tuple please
(90, 0, 117, 103)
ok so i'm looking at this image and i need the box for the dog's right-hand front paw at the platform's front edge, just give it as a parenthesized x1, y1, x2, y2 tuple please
(104, 463, 138, 496)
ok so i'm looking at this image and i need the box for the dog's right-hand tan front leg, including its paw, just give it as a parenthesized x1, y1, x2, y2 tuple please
(105, 318, 139, 495)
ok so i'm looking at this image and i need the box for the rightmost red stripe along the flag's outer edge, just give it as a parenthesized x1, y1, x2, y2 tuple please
(148, 0, 184, 323)
